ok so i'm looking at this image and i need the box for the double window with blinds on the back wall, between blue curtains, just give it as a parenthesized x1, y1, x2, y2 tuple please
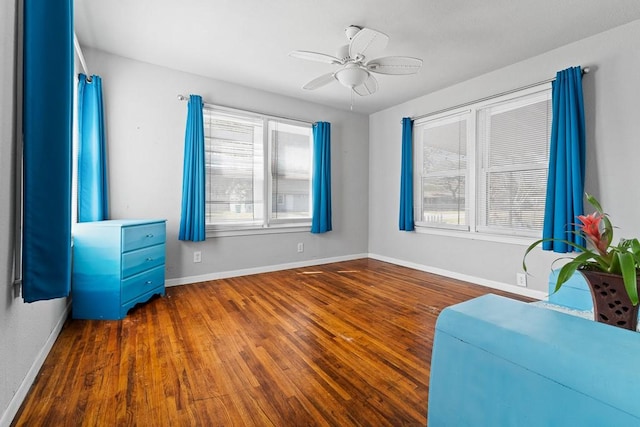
(203, 107, 312, 234)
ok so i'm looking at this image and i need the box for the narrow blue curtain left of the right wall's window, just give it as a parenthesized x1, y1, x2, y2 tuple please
(399, 117, 414, 231)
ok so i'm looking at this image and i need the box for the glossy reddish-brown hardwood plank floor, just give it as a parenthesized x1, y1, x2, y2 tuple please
(13, 259, 526, 426)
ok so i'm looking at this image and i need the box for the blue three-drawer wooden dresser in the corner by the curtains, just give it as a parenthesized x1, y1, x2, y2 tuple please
(71, 220, 166, 320)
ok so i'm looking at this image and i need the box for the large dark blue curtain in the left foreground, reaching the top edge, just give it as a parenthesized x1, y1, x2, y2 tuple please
(22, 0, 73, 302)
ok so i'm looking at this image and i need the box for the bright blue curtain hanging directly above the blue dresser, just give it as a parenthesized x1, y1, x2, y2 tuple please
(78, 74, 109, 222)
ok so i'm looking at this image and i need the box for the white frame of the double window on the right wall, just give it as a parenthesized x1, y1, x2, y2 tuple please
(413, 82, 551, 244)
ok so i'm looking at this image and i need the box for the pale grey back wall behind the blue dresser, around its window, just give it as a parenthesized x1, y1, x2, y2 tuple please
(84, 49, 369, 284)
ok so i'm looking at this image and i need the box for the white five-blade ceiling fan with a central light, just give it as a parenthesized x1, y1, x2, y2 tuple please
(289, 25, 422, 96)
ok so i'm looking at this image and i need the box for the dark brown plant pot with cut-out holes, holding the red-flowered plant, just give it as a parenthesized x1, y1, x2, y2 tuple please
(579, 270, 640, 331)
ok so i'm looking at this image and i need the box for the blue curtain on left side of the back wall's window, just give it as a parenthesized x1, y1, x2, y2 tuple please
(178, 95, 206, 242)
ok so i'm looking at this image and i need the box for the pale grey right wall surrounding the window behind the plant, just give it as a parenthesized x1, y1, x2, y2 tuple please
(369, 21, 640, 291)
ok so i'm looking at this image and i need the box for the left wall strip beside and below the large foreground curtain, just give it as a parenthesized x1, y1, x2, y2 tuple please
(0, 1, 66, 426)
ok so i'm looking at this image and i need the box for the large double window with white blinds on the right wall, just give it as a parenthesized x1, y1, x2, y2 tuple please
(414, 85, 552, 236)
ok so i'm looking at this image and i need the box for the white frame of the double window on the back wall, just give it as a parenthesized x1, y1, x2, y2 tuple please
(203, 104, 313, 237)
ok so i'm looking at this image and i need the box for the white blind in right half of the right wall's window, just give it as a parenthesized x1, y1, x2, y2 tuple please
(478, 93, 552, 231)
